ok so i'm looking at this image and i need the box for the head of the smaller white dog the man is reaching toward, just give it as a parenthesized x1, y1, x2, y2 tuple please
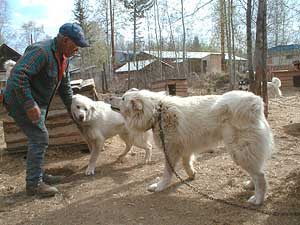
(71, 94, 96, 123)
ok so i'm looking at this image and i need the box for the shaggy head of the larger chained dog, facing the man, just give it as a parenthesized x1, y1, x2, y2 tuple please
(110, 90, 165, 131)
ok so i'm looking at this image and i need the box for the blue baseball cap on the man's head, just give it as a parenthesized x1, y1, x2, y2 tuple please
(59, 23, 89, 48)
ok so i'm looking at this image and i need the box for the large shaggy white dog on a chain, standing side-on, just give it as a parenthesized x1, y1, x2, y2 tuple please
(112, 90, 273, 204)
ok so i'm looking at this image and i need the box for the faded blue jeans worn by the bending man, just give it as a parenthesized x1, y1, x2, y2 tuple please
(14, 113, 49, 186)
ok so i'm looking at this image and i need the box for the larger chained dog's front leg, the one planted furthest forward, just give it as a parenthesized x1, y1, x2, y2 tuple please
(148, 148, 180, 192)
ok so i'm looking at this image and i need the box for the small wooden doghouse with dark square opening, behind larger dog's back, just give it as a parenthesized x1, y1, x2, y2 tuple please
(151, 78, 188, 97)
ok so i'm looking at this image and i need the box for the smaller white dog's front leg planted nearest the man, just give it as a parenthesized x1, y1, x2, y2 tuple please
(85, 137, 104, 175)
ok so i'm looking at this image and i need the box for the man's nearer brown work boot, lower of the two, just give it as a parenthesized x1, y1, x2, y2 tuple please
(26, 182, 59, 198)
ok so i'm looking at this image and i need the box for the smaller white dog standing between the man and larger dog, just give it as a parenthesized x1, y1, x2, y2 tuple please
(71, 94, 152, 175)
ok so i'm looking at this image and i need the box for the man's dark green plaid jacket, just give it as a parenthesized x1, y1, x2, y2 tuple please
(4, 38, 73, 119)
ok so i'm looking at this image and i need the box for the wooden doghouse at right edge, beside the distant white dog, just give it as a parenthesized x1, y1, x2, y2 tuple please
(271, 70, 300, 88)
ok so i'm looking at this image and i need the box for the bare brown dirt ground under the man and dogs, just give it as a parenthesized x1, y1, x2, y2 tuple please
(0, 90, 300, 225)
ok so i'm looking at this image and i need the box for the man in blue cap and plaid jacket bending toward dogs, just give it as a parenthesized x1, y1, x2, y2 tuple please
(4, 23, 88, 197)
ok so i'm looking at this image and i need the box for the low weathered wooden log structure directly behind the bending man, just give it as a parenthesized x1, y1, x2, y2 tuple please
(3, 79, 98, 153)
